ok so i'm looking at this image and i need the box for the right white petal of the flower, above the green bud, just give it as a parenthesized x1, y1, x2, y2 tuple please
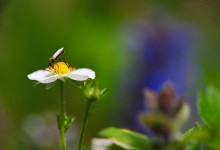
(67, 68, 95, 81)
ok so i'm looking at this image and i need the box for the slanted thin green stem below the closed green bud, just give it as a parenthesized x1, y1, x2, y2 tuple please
(78, 100, 92, 150)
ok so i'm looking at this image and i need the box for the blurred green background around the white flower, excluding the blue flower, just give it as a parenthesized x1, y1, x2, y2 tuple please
(0, 0, 220, 150)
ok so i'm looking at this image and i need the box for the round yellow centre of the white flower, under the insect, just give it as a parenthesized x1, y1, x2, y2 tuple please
(54, 62, 70, 75)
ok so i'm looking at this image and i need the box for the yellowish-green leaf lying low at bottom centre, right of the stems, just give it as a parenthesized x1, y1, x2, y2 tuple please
(100, 127, 151, 150)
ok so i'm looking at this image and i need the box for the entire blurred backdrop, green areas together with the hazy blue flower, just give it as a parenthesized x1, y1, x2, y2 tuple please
(0, 0, 220, 150)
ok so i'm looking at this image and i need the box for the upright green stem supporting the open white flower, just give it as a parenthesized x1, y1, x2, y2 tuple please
(60, 81, 66, 150)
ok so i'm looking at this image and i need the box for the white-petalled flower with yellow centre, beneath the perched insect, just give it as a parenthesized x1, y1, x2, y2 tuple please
(27, 62, 95, 84)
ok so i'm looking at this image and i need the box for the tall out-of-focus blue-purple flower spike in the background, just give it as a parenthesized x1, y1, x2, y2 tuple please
(120, 12, 198, 131)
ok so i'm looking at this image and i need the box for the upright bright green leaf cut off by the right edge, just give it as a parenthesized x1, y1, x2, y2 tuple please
(198, 86, 220, 135)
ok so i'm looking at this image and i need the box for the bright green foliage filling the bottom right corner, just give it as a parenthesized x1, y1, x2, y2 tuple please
(167, 86, 220, 150)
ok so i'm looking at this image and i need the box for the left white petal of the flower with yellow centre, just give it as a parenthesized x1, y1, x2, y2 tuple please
(28, 70, 59, 84)
